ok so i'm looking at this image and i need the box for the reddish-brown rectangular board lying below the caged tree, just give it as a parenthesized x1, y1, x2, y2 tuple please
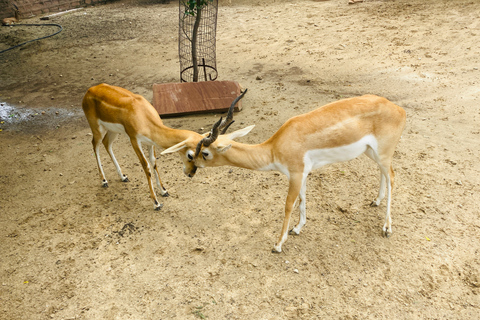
(152, 81, 243, 117)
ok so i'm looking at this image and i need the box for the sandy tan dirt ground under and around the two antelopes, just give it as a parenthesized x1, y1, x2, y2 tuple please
(0, 0, 480, 320)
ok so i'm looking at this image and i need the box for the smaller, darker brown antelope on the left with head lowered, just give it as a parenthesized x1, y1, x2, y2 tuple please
(82, 84, 208, 210)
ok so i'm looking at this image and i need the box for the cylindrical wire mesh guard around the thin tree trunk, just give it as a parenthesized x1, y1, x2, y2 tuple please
(178, 0, 218, 82)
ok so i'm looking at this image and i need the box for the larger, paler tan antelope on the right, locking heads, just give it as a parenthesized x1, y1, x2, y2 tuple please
(162, 95, 406, 252)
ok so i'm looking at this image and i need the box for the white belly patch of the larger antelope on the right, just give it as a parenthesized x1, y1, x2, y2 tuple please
(303, 134, 378, 172)
